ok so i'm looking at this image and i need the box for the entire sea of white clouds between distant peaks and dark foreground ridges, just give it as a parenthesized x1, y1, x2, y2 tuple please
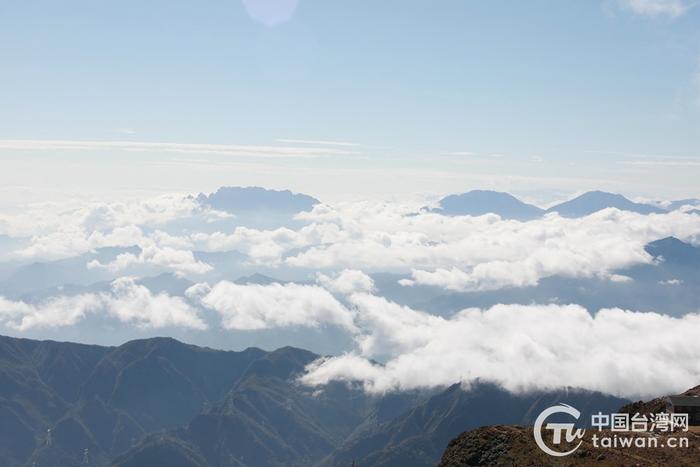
(0, 195, 700, 397)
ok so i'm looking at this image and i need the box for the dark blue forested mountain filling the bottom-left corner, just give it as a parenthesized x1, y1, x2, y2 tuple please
(0, 337, 266, 467)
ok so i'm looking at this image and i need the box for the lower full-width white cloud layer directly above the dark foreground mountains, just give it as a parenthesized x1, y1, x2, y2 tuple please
(0, 270, 700, 398)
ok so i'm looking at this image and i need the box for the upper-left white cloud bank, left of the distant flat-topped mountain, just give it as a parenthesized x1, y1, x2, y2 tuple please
(0, 194, 222, 274)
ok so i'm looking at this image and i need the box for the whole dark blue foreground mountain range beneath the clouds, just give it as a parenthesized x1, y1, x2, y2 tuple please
(0, 337, 627, 467)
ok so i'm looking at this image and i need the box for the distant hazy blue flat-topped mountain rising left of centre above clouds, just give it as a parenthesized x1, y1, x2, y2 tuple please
(197, 187, 320, 214)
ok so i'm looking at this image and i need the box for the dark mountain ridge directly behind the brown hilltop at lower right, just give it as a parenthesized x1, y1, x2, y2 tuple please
(319, 383, 625, 467)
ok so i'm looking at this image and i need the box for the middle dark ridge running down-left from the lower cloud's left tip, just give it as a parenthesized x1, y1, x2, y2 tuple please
(115, 348, 378, 467)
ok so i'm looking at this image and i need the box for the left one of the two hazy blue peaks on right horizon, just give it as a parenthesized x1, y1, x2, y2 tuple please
(433, 190, 544, 221)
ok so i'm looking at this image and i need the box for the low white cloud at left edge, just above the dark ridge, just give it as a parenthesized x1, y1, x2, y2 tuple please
(0, 277, 207, 331)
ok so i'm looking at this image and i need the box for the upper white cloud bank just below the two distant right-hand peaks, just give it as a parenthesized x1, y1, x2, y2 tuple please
(292, 204, 700, 290)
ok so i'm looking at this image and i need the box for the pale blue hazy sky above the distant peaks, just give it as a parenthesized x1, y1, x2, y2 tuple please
(0, 0, 700, 206)
